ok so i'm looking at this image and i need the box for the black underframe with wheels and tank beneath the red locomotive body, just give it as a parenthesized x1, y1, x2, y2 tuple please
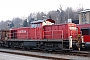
(1, 39, 76, 51)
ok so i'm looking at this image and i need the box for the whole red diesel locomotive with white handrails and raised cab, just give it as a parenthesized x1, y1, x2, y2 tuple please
(1, 19, 82, 51)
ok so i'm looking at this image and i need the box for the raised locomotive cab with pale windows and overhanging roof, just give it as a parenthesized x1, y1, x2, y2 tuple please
(30, 19, 55, 40)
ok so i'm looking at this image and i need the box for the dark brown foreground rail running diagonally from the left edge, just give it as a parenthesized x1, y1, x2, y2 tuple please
(0, 49, 70, 60)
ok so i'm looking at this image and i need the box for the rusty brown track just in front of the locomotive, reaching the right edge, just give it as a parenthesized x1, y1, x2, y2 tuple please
(21, 50, 90, 57)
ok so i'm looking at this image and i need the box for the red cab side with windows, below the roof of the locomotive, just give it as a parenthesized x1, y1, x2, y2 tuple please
(30, 23, 42, 40)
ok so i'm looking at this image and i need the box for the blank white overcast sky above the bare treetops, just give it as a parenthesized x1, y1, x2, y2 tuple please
(0, 0, 90, 21)
